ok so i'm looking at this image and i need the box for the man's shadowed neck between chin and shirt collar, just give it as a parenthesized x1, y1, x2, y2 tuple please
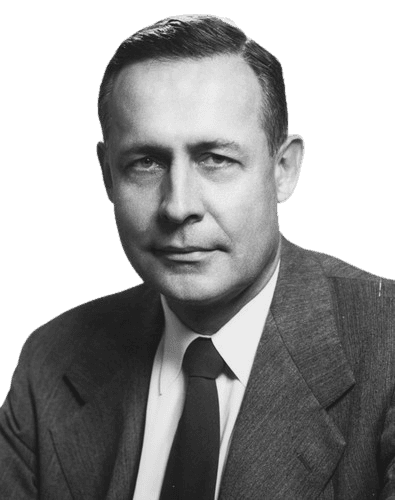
(166, 247, 280, 335)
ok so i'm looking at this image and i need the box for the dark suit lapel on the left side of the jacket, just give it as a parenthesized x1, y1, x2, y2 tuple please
(50, 291, 163, 499)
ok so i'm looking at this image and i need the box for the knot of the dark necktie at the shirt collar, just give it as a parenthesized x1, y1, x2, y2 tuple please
(182, 337, 224, 379)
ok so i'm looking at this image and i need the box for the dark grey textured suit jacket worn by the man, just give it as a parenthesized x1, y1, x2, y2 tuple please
(0, 239, 395, 500)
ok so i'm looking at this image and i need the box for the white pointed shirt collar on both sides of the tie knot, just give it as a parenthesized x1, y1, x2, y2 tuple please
(159, 262, 280, 394)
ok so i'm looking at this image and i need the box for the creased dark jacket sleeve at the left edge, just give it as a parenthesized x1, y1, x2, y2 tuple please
(0, 354, 38, 500)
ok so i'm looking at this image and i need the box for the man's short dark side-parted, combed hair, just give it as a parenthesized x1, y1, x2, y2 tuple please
(98, 14, 288, 156)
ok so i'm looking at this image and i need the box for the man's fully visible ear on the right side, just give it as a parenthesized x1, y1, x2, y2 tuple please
(274, 135, 304, 203)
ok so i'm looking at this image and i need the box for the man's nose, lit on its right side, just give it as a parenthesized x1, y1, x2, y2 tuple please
(160, 162, 204, 225)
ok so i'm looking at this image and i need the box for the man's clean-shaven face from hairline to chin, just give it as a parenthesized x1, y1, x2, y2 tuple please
(103, 56, 286, 305)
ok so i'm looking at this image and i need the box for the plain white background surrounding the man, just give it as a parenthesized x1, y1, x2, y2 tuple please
(0, 0, 395, 402)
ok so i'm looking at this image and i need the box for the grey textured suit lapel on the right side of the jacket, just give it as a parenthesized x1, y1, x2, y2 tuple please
(220, 240, 354, 500)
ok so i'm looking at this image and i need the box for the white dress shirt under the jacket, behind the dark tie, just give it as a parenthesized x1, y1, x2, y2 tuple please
(133, 264, 279, 500)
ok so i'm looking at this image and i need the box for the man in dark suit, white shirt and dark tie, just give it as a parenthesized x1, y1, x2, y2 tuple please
(0, 16, 395, 500)
